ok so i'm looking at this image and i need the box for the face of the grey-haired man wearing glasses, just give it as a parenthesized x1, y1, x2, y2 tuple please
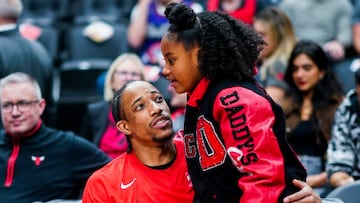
(0, 83, 45, 136)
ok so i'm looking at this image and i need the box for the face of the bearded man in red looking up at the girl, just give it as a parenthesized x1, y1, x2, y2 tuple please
(117, 81, 174, 149)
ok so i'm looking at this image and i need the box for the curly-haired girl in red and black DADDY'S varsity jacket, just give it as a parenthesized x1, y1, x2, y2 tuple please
(161, 3, 306, 202)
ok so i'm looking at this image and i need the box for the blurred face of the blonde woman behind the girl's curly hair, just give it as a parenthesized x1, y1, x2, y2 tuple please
(254, 20, 276, 60)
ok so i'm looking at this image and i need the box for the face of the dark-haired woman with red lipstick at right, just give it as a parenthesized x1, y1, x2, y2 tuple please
(292, 54, 325, 92)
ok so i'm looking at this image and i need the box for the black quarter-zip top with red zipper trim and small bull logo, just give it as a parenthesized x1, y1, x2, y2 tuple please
(0, 122, 110, 203)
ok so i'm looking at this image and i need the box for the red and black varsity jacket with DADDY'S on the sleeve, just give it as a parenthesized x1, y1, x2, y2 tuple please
(184, 79, 306, 203)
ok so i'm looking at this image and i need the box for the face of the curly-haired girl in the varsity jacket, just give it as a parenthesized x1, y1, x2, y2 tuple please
(161, 34, 202, 93)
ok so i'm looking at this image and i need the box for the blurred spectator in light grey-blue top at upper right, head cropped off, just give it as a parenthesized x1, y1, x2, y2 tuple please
(279, 0, 352, 61)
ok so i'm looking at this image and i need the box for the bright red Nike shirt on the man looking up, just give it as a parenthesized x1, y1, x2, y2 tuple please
(82, 138, 194, 203)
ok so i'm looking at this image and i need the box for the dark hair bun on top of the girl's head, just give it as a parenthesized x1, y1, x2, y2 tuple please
(165, 3, 196, 30)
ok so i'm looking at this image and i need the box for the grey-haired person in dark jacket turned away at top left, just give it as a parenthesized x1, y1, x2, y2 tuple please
(0, 0, 56, 126)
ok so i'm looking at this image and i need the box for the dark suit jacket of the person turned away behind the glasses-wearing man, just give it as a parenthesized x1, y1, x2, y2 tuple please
(0, 29, 56, 126)
